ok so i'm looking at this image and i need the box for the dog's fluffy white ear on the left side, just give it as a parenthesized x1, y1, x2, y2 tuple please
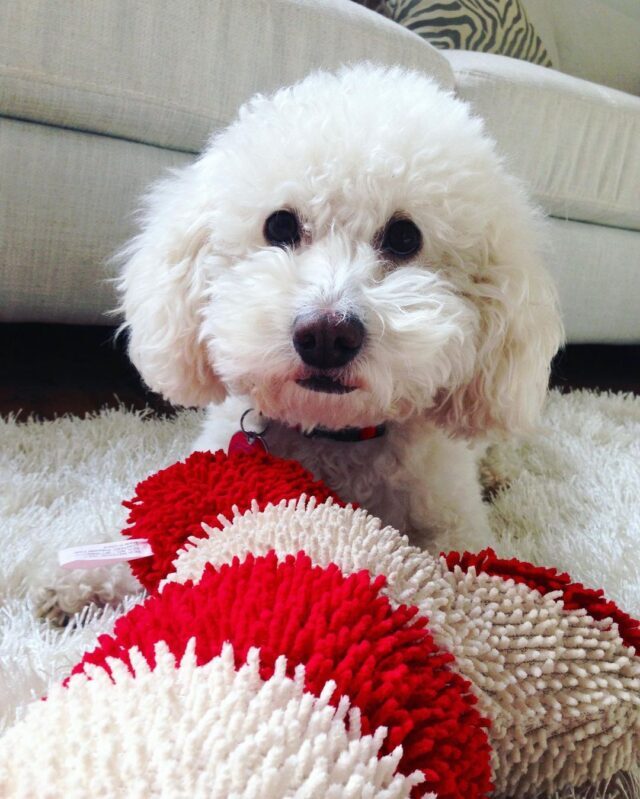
(118, 163, 225, 405)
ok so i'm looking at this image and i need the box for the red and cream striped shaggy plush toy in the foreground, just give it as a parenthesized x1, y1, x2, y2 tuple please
(0, 450, 640, 799)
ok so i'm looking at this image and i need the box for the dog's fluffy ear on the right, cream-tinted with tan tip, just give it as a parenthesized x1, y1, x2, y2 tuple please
(435, 219, 563, 437)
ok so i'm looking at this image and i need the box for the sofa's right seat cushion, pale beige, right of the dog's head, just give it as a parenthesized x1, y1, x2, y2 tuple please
(443, 50, 640, 230)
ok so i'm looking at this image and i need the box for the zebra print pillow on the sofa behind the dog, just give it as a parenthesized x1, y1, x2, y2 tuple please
(385, 0, 553, 67)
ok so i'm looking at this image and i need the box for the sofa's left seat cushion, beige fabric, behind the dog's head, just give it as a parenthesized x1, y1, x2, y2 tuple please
(0, 0, 453, 152)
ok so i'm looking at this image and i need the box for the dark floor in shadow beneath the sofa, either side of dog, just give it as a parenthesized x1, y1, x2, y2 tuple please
(0, 324, 640, 419)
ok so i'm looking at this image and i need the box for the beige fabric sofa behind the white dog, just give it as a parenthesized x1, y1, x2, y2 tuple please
(0, 0, 640, 342)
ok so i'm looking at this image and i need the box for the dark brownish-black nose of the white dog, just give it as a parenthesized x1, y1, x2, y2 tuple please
(293, 314, 365, 369)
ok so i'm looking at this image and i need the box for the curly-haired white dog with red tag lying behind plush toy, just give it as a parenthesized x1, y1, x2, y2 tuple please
(120, 64, 562, 549)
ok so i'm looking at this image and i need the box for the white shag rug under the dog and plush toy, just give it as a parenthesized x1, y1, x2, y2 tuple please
(0, 392, 640, 732)
